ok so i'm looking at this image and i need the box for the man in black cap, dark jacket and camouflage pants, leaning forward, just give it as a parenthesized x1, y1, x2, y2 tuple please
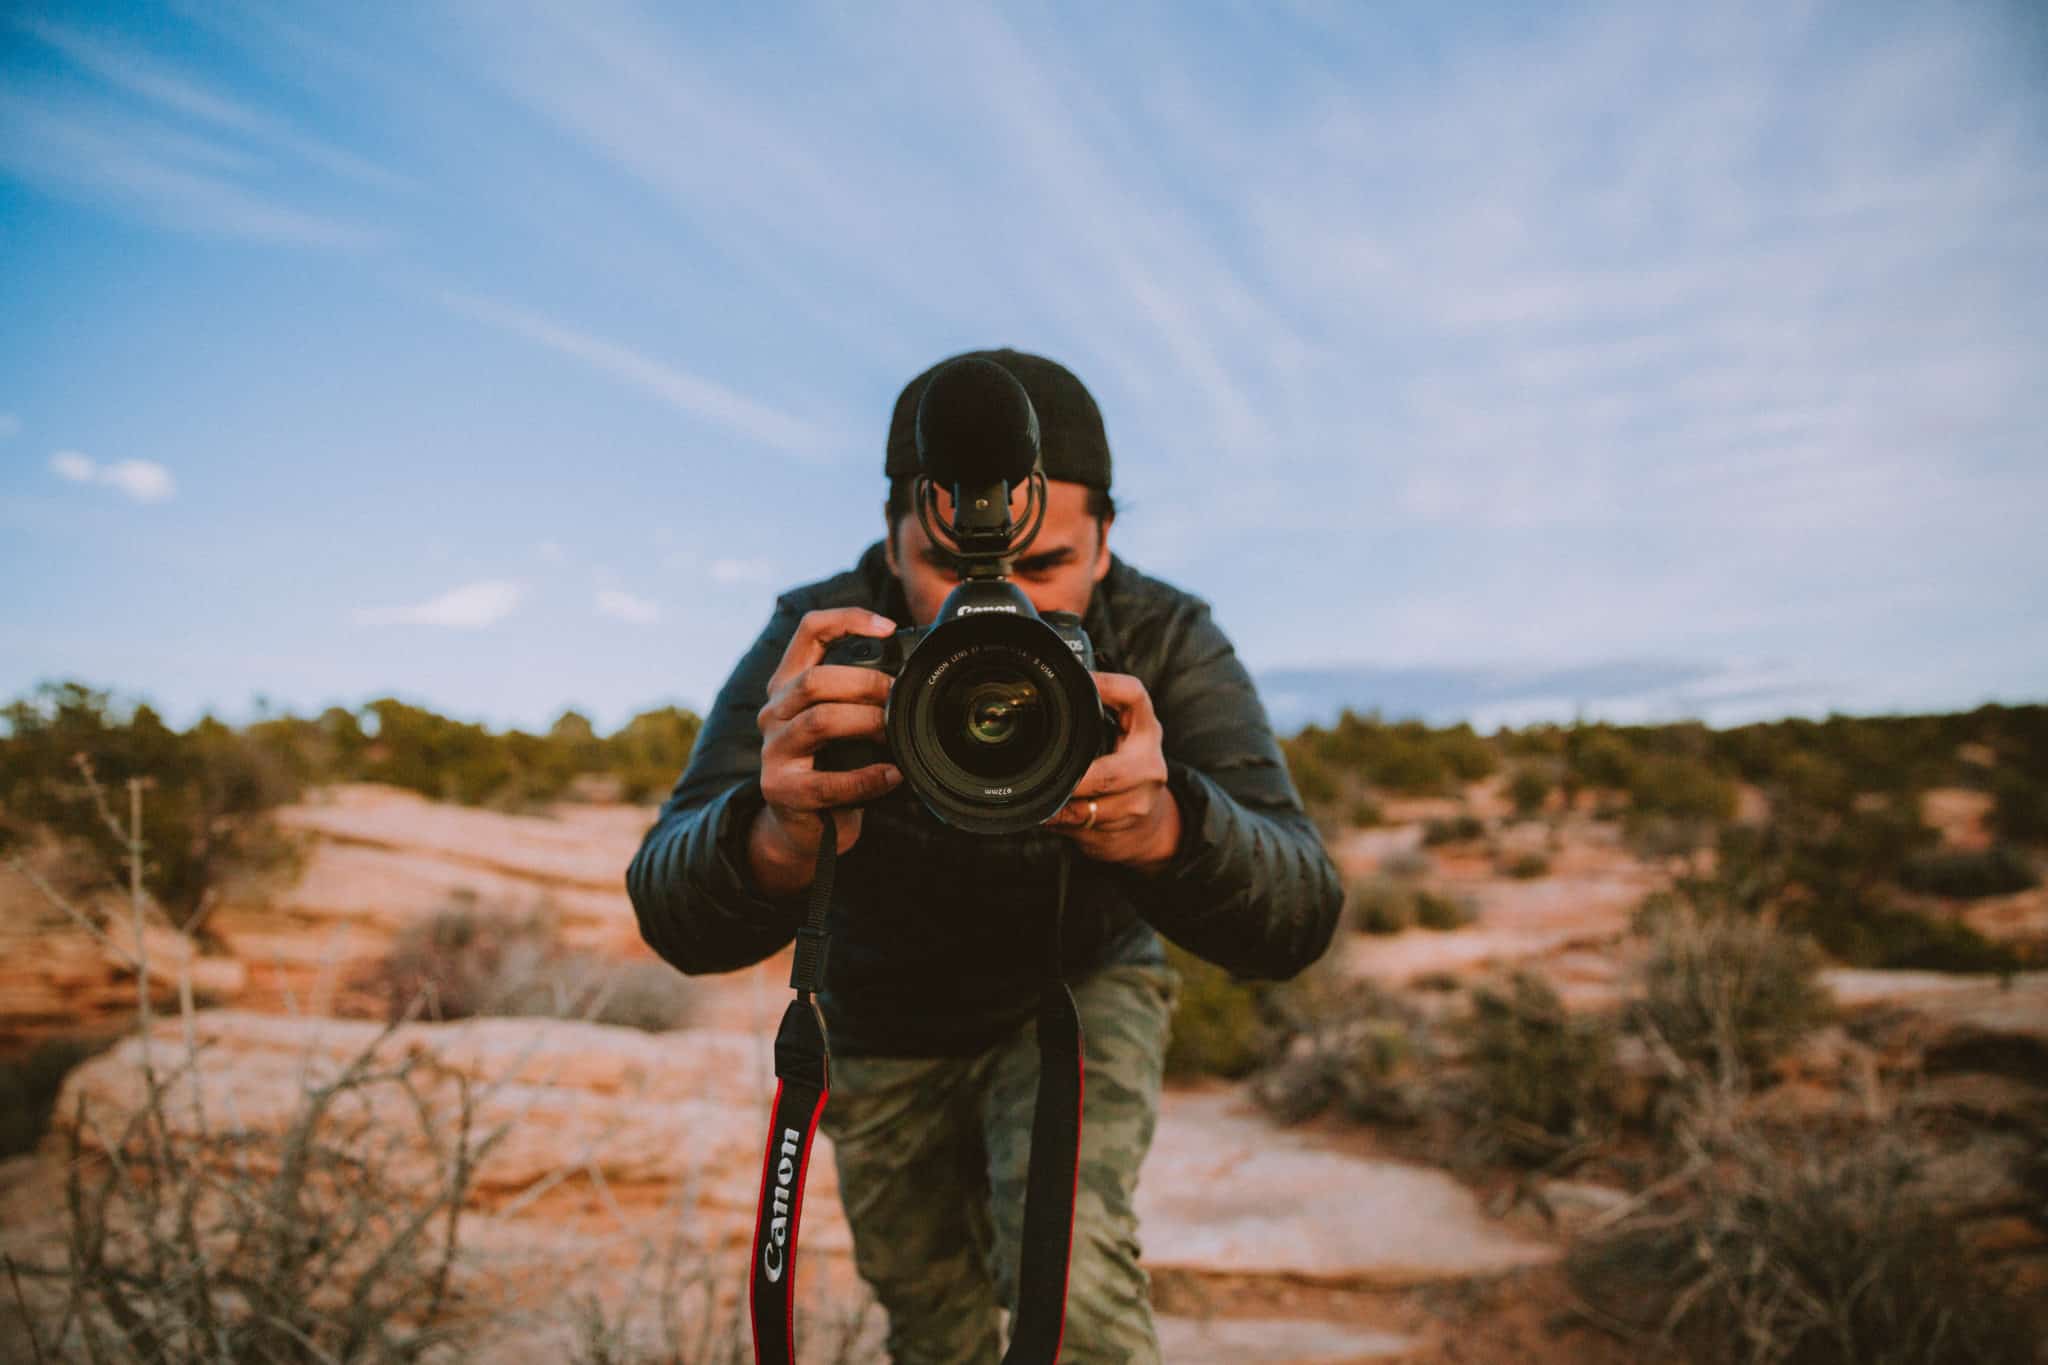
(627, 350, 1341, 1365)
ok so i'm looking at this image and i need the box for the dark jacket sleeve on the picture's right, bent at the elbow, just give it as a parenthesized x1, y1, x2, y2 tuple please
(1133, 602, 1343, 980)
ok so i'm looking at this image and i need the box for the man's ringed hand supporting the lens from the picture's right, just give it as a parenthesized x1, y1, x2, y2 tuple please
(1044, 673, 1180, 872)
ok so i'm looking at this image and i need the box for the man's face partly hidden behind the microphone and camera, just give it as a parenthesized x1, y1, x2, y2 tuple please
(885, 479, 1110, 626)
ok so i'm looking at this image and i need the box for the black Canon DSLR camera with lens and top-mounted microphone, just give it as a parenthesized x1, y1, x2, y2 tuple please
(817, 358, 1118, 835)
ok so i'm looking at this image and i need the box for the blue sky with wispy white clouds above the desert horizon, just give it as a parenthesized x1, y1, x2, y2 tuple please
(0, 0, 2048, 729)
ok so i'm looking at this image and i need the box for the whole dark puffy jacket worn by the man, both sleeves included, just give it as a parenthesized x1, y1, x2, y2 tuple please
(627, 542, 1343, 1056)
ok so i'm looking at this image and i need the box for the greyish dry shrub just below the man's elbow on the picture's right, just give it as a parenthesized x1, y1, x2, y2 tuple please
(1251, 974, 1436, 1124)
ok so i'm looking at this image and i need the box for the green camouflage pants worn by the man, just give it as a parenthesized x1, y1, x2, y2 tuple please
(823, 966, 1178, 1365)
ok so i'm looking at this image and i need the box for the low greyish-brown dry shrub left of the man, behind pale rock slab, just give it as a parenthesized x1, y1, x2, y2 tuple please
(380, 894, 692, 1033)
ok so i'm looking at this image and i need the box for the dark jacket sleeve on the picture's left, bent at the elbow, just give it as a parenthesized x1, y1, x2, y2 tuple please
(627, 600, 803, 974)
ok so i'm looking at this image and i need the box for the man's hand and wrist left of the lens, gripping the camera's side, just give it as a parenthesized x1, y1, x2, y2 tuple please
(748, 606, 903, 896)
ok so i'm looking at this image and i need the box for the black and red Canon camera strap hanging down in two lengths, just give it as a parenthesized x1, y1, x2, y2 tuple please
(748, 810, 1083, 1365)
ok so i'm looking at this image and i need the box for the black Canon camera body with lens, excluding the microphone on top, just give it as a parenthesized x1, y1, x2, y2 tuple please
(817, 577, 1118, 833)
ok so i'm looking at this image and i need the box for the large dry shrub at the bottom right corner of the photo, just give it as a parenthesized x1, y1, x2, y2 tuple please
(1567, 1132, 2038, 1365)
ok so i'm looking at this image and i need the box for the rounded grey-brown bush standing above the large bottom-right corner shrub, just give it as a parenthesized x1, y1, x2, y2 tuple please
(1636, 898, 1829, 1078)
